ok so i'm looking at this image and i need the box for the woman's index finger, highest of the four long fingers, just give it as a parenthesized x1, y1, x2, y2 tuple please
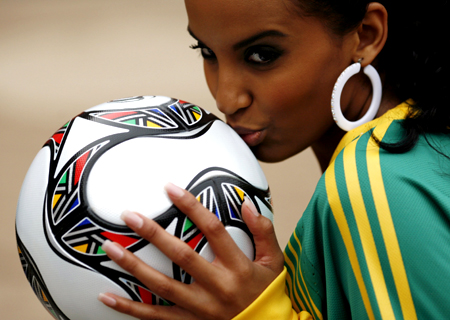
(165, 183, 246, 266)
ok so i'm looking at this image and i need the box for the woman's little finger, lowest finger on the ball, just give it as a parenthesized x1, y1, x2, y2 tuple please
(98, 293, 195, 320)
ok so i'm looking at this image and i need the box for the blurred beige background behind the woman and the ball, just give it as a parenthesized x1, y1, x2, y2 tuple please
(0, 0, 320, 320)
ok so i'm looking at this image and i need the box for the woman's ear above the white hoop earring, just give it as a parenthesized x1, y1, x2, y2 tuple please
(354, 2, 388, 67)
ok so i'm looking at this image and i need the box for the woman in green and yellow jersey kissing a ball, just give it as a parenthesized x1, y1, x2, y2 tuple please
(99, 0, 450, 319)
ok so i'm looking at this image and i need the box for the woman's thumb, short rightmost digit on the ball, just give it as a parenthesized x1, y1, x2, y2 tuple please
(241, 198, 284, 272)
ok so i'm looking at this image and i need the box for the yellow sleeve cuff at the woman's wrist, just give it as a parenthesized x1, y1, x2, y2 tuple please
(233, 268, 313, 320)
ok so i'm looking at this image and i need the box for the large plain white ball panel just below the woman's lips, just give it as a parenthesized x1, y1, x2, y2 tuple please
(87, 121, 267, 225)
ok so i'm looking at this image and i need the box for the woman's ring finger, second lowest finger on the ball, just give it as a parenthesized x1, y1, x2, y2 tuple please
(102, 240, 192, 306)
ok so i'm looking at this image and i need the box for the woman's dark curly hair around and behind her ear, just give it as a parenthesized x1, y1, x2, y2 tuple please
(292, 0, 450, 153)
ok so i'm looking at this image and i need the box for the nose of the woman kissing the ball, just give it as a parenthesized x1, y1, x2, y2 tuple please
(215, 70, 252, 115)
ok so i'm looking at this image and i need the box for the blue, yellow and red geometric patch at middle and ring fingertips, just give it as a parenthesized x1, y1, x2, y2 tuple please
(62, 218, 142, 255)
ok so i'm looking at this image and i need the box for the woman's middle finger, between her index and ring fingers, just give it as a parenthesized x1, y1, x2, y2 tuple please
(121, 211, 218, 285)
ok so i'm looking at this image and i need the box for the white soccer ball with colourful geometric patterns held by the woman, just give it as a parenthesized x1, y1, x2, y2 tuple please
(16, 96, 272, 320)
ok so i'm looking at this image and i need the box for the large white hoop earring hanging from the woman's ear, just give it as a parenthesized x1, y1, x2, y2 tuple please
(331, 61, 382, 131)
